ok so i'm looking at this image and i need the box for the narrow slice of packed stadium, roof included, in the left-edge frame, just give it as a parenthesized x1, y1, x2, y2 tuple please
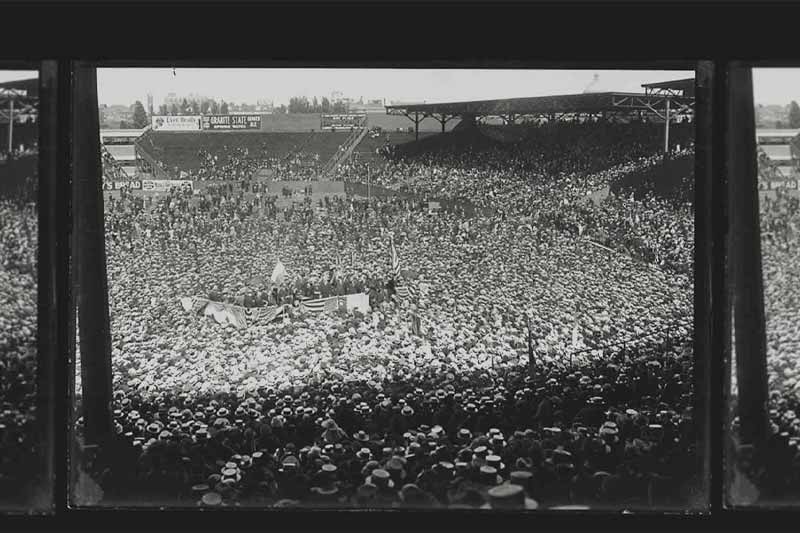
(0, 71, 43, 502)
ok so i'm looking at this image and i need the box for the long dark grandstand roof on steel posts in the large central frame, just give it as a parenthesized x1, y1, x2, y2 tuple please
(386, 92, 694, 116)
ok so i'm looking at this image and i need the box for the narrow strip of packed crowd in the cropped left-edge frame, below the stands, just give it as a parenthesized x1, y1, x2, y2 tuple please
(0, 189, 40, 503)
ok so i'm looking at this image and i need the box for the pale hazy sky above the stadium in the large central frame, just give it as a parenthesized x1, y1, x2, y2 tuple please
(97, 68, 694, 107)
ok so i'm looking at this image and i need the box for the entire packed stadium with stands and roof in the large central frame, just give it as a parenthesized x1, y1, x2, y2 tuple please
(76, 72, 700, 510)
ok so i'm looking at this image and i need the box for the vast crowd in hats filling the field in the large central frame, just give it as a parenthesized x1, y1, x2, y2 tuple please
(78, 117, 696, 509)
